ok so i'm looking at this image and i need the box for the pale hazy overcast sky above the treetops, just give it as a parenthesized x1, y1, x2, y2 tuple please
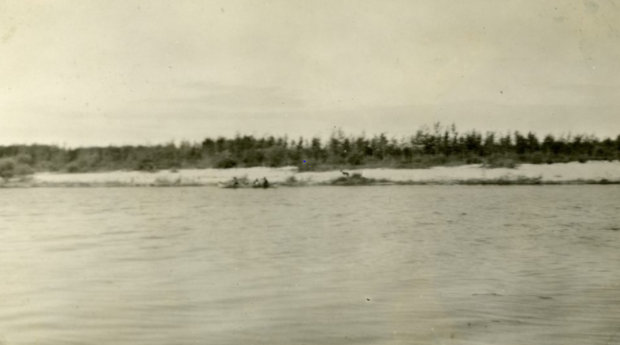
(0, 0, 620, 146)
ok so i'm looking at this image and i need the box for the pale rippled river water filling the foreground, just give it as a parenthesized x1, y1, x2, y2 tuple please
(0, 186, 620, 345)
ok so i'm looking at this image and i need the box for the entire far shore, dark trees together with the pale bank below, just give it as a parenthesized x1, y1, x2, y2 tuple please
(0, 123, 620, 187)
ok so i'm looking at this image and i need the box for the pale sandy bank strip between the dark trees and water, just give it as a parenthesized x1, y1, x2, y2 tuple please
(4, 161, 620, 187)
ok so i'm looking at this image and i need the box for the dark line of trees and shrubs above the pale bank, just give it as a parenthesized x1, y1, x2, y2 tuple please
(0, 123, 620, 173)
